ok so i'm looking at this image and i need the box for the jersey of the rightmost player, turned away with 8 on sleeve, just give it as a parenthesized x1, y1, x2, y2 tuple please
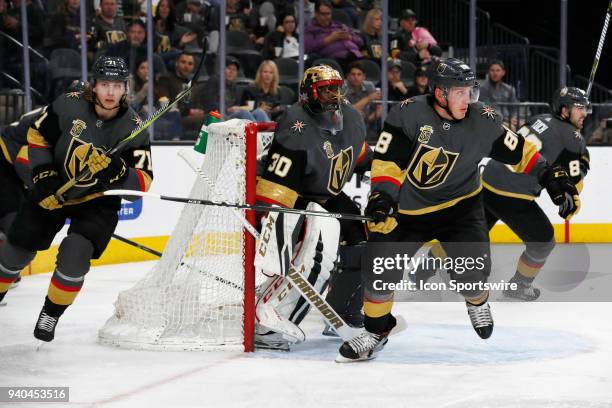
(482, 113, 590, 200)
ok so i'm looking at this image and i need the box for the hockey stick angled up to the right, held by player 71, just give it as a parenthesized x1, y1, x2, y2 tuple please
(55, 47, 206, 203)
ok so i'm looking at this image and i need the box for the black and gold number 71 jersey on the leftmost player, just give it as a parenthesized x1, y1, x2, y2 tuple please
(27, 92, 153, 204)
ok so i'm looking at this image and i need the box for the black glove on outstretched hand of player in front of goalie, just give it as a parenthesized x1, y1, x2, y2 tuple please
(540, 166, 580, 220)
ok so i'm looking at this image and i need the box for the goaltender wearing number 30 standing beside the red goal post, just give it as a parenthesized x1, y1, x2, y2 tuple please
(256, 65, 372, 345)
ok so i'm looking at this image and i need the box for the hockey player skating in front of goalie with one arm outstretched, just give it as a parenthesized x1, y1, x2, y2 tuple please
(336, 58, 577, 362)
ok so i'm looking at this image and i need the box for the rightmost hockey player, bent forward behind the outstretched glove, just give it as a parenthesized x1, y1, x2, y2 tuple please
(482, 87, 589, 300)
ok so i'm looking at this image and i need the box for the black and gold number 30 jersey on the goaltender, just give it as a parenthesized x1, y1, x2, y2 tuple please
(257, 103, 372, 207)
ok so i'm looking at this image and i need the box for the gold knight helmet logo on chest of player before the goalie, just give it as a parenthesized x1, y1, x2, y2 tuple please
(407, 144, 459, 189)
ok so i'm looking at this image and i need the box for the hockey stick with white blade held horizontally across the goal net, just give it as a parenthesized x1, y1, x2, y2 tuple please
(103, 190, 372, 221)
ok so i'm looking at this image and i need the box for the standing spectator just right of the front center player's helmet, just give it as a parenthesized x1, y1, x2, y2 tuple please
(479, 60, 518, 130)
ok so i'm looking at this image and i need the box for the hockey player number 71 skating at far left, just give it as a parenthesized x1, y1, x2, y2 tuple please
(0, 57, 153, 341)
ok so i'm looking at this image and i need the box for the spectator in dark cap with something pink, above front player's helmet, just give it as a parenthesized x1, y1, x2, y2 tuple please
(391, 9, 442, 66)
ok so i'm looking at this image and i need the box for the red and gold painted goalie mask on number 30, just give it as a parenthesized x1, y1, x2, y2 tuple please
(300, 65, 344, 132)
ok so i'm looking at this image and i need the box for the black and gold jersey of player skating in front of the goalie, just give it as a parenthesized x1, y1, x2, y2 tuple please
(372, 96, 546, 215)
